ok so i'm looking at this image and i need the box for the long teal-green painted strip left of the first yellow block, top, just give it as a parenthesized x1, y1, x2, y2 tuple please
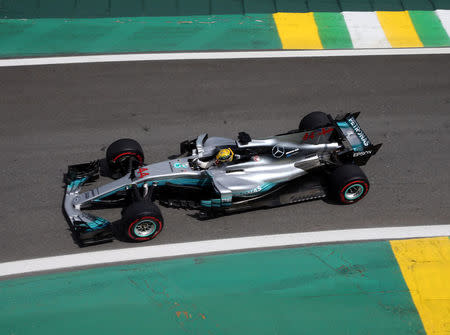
(0, 14, 281, 57)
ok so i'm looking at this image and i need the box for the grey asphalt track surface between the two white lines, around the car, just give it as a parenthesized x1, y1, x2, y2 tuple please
(0, 55, 450, 262)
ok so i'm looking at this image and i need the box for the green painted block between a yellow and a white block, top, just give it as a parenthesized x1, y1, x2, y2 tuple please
(314, 13, 353, 49)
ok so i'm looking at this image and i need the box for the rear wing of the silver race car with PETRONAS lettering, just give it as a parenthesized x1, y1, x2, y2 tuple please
(329, 112, 382, 165)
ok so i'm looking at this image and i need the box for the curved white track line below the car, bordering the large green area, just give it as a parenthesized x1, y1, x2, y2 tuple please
(0, 225, 450, 277)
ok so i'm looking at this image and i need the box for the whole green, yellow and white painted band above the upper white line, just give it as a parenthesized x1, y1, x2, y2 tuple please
(0, 10, 450, 58)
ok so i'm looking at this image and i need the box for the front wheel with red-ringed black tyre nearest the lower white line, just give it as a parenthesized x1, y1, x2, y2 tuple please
(121, 201, 164, 242)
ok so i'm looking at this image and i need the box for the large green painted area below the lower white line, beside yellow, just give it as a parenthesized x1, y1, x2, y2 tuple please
(0, 242, 425, 335)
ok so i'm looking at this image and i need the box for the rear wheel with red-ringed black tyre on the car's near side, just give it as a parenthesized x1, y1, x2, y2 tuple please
(329, 164, 370, 205)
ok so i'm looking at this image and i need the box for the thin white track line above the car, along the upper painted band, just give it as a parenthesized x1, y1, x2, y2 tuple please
(0, 47, 450, 67)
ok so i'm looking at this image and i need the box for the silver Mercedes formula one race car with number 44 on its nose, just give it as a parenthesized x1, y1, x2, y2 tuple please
(64, 112, 381, 245)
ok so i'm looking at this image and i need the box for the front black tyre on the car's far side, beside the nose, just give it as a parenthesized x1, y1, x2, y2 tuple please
(106, 138, 144, 175)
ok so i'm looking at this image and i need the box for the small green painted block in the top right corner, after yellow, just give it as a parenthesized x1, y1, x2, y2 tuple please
(409, 11, 450, 47)
